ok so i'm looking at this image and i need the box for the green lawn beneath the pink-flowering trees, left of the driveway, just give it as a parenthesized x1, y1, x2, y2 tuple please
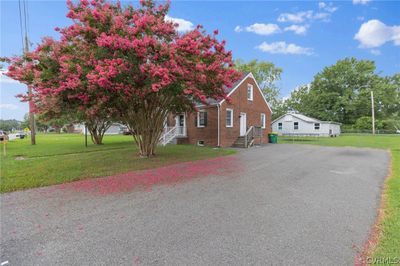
(0, 134, 235, 192)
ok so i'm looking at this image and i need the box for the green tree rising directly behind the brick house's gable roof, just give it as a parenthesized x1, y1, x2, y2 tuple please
(235, 59, 282, 108)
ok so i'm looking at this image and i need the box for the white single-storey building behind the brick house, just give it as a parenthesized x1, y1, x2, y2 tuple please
(272, 113, 341, 137)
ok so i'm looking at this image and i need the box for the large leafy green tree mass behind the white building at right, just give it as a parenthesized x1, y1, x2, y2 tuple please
(288, 58, 400, 124)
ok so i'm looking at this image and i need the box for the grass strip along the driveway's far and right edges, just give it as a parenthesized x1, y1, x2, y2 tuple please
(279, 135, 400, 258)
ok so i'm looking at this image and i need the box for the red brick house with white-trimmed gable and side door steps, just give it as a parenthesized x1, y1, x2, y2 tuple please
(161, 73, 271, 147)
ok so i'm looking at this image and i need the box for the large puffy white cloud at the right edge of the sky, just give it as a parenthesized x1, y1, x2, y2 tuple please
(354, 19, 400, 48)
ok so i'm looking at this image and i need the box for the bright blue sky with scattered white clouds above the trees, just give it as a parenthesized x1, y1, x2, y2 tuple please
(0, 0, 400, 120)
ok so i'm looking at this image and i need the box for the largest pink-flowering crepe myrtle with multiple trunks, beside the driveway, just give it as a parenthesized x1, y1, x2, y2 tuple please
(5, 0, 240, 157)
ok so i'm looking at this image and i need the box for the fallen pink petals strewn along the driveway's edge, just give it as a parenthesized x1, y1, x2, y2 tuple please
(55, 156, 241, 195)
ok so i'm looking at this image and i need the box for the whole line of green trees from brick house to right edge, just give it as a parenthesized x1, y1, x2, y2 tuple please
(236, 58, 400, 131)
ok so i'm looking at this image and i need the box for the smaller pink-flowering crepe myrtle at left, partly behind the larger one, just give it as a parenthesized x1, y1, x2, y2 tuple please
(4, 38, 116, 145)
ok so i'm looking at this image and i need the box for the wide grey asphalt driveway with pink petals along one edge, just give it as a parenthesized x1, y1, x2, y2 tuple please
(0, 145, 389, 265)
